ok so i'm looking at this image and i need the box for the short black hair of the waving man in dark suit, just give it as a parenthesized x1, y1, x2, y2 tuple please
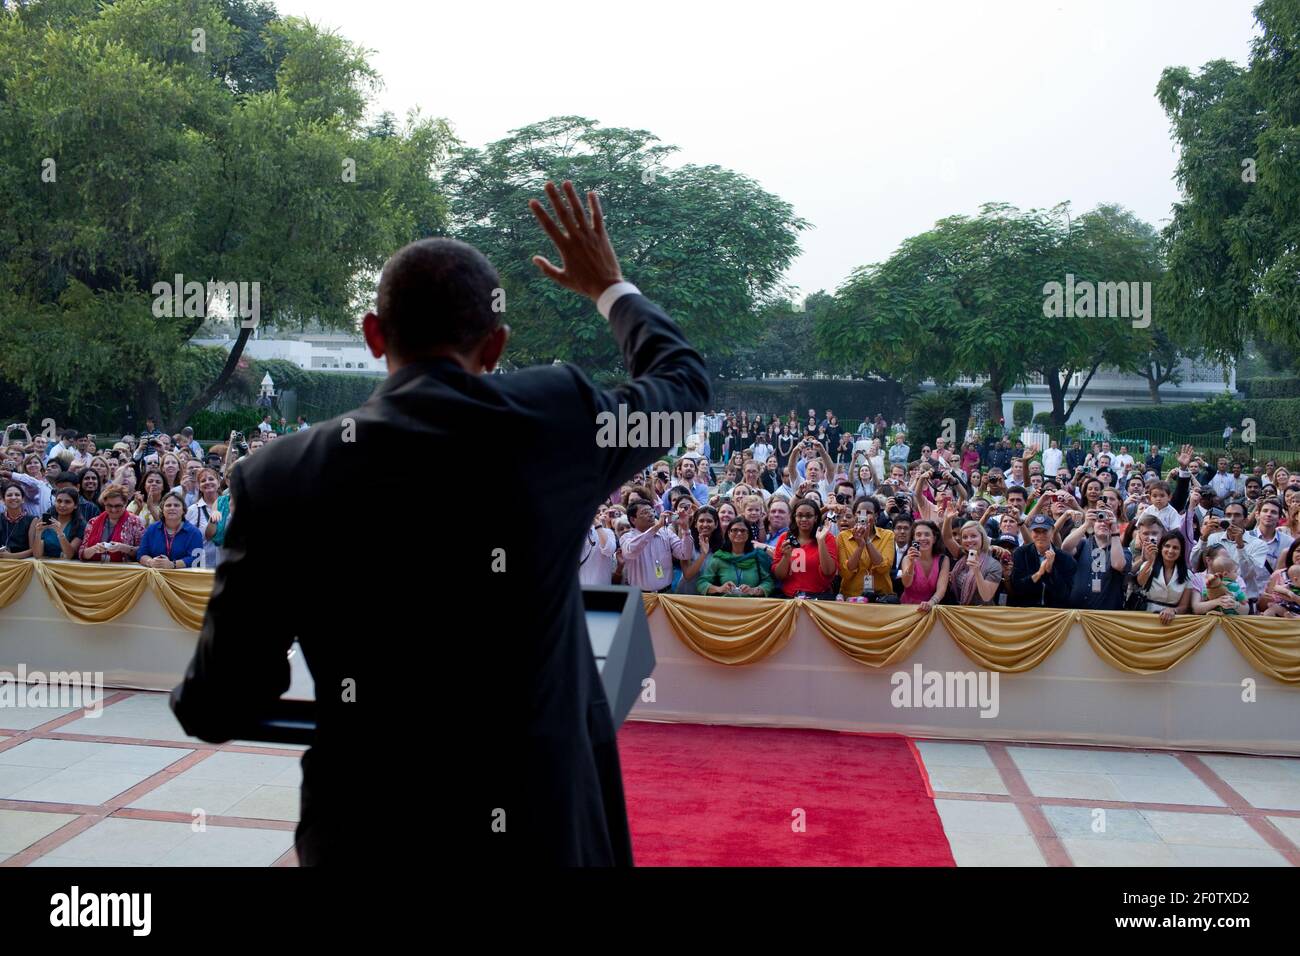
(376, 239, 501, 358)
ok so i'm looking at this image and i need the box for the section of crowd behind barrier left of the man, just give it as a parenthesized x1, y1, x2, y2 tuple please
(0, 414, 309, 568)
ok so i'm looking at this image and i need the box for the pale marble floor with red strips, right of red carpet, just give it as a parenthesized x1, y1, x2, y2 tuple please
(917, 740, 1300, 866)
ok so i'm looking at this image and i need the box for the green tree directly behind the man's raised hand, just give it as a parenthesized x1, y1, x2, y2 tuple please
(443, 116, 807, 369)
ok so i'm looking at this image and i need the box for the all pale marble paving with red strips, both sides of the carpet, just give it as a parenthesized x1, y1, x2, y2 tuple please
(0, 691, 1300, 866)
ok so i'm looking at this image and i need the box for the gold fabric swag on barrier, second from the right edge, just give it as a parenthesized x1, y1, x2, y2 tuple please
(1079, 611, 1211, 674)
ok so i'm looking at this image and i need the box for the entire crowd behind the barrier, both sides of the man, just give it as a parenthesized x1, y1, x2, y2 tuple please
(10, 410, 1300, 622)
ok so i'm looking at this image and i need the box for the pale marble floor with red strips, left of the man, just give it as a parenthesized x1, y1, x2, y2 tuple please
(0, 691, 304, 866)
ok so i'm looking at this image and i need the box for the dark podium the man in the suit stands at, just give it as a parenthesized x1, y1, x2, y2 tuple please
(243, 585, 655, 745)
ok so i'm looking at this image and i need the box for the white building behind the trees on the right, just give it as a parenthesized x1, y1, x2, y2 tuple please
(941, 359, 1236, 432)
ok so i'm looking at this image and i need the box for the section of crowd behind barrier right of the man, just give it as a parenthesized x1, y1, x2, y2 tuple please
(579, 410, 1300, 623)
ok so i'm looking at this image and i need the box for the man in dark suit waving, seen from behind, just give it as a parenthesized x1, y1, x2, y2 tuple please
(172, 182, 710, 865)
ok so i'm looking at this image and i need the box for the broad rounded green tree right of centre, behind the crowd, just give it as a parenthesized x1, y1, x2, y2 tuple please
(818, 203, 1156, 425)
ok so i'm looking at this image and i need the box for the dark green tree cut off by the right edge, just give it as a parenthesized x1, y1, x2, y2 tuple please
(1156, 0, 1300, 362)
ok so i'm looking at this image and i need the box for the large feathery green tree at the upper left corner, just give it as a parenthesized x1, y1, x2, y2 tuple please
(0, 0, 454, 427)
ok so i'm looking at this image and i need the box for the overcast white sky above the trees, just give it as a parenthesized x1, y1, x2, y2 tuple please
(276, 0, 1256, 294)
